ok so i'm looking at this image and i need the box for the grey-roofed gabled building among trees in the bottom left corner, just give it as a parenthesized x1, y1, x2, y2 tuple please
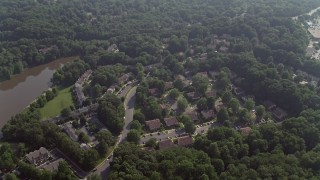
(26, 147, 50, 165)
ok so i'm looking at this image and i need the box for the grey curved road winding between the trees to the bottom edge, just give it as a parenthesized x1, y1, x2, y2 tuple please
(94, 86, 137, 180)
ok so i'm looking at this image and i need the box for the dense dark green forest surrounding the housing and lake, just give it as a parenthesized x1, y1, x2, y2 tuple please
(0, 0, 320, 180)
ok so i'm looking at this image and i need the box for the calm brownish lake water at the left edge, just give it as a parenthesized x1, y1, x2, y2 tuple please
(0, 57, 78, 129)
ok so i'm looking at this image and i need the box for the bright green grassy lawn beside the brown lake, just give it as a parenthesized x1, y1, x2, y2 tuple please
(40, 86, 73, 119)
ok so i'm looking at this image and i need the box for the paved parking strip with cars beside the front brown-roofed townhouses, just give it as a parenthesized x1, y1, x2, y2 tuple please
(140, 121, 219, 144)
